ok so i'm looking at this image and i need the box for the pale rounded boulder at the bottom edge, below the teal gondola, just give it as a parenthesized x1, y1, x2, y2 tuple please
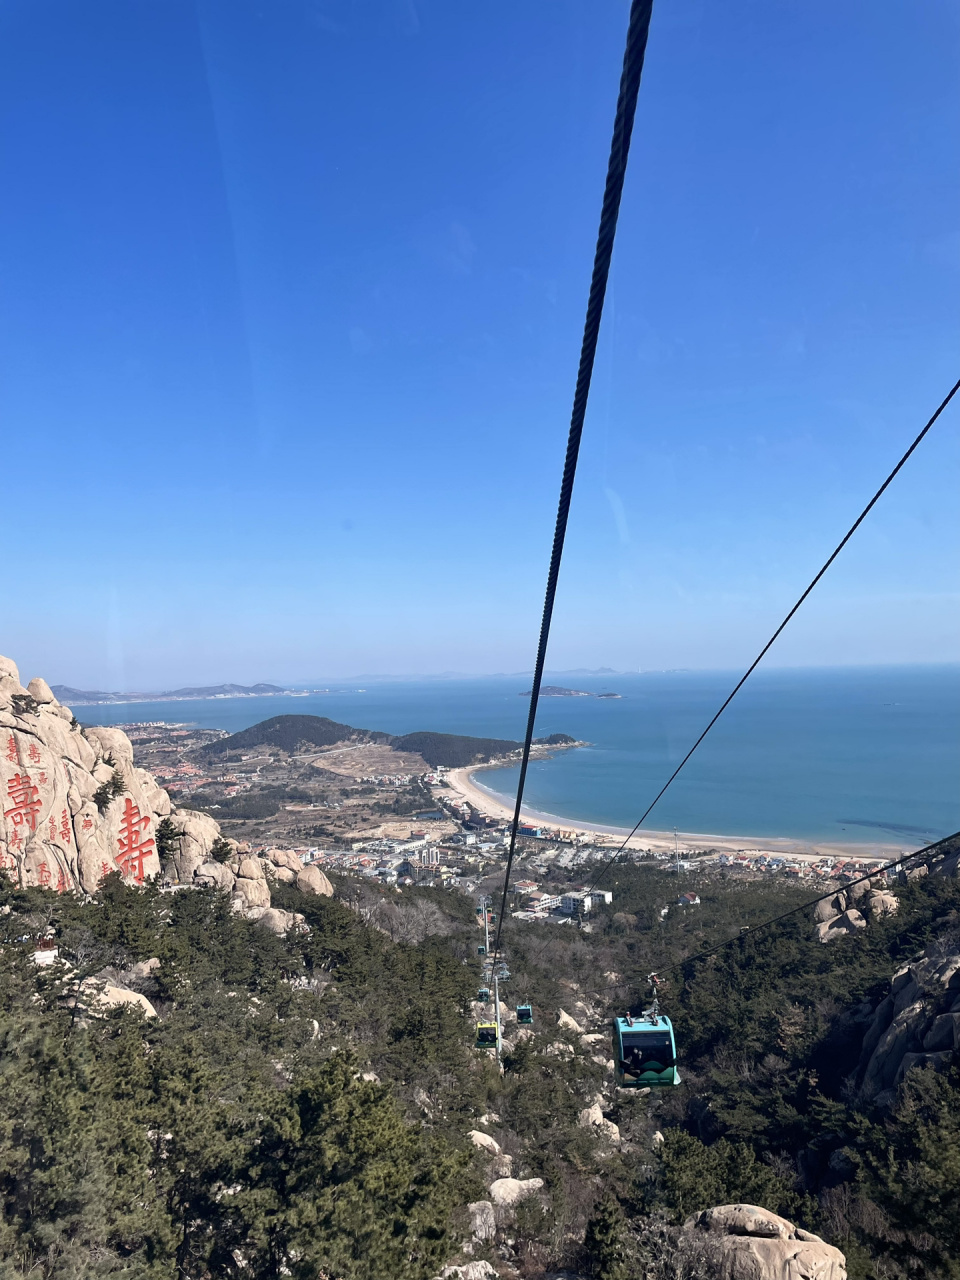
(685, 1204, 846, 1280)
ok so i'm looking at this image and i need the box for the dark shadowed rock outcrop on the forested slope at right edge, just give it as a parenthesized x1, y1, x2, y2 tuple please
(859, 942, 960, 1106)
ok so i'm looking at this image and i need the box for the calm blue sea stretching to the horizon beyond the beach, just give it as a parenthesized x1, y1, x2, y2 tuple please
(77, 664, 960, 849)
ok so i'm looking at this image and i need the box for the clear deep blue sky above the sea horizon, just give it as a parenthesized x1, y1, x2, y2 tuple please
(0, 0, 960, 689)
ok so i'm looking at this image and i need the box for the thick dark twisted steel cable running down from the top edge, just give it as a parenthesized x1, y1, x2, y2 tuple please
(493, 0, 653, 956)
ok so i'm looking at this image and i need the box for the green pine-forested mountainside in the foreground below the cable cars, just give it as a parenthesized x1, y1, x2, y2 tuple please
(0, 865, 960, 1280)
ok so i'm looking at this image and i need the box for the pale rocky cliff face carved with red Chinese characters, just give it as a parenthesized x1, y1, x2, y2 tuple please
(0, 657, 333, 929)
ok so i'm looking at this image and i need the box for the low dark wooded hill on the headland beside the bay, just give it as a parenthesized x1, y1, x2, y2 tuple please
(197, 716, 575, 769)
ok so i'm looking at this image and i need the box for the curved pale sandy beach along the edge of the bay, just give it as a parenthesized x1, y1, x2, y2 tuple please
(445, 763, 920, 860)
